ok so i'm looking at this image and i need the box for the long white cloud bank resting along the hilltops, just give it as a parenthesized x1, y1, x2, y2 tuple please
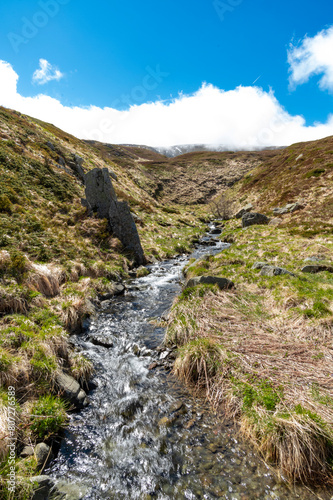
(0, 61, 333, 149)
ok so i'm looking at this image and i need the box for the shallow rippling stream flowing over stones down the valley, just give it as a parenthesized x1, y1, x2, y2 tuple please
(48, 230, 324, 500)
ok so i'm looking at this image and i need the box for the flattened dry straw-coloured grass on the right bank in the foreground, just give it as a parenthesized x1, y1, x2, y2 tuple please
(167, 290, 333, 481)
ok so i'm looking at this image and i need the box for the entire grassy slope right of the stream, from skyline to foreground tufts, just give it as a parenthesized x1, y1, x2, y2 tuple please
(166, 137, 333, 485)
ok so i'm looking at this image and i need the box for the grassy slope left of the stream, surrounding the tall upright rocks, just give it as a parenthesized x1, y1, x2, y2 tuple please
(0, 108, 205, 498)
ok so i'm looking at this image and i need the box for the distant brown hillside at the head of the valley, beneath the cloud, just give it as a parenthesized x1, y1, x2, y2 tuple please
(84, 141, 279, 206)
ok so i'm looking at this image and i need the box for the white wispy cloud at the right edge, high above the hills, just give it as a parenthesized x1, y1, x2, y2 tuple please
(288, 26, 333, 91)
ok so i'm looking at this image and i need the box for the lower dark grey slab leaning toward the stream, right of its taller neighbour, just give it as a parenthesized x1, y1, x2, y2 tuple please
(109, 201, 145, 265)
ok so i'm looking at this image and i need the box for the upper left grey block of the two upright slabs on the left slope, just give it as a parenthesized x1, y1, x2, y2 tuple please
(85, 168, 117, 219)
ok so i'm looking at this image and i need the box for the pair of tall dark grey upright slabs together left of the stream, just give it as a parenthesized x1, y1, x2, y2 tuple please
(82, 168, 145, 265)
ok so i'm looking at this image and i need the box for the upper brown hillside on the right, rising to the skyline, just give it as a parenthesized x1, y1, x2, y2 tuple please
(230, 137, 333, 236)
